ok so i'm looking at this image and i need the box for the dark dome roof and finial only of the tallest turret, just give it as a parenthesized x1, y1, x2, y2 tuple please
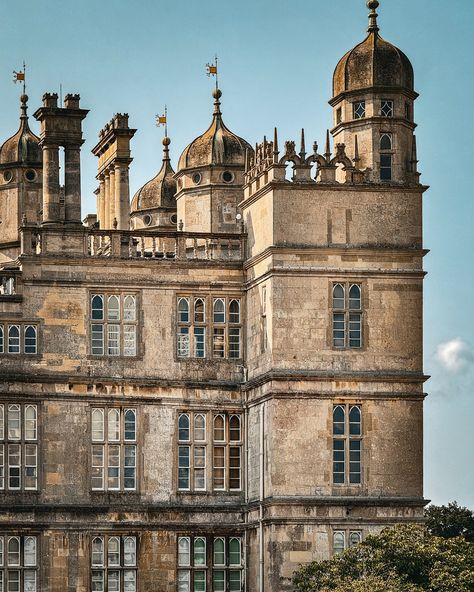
(333, 0, 414, 97)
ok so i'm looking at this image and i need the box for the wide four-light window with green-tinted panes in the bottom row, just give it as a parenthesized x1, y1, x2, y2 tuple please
(176, 536, 245, 592)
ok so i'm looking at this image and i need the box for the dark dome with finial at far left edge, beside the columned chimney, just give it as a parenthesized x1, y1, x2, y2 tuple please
(0, 95, 43, 165)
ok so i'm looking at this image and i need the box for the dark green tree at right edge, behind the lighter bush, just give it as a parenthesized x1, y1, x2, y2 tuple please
(425, 502, 474, 542)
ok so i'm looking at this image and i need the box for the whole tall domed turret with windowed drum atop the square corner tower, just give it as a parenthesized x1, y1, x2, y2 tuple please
(329, 0, 419, 185)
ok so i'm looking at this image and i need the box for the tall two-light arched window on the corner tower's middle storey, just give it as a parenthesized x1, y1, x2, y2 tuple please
(332, 405, 362, 485)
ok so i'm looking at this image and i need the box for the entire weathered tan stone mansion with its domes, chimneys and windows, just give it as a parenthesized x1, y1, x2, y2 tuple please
(0, 0, 426, 592)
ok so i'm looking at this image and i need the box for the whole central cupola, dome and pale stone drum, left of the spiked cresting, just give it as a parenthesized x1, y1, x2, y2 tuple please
(175, 88, 254, 233)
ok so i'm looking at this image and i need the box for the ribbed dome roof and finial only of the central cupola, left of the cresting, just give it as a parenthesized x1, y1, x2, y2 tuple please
(178, 89, 253, 171)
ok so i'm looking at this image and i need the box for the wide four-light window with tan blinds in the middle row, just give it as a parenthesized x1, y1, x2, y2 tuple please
(178, 412, 242, 491)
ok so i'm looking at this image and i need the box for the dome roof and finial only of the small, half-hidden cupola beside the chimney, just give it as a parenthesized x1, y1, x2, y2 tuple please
(130, 137, 176, 214)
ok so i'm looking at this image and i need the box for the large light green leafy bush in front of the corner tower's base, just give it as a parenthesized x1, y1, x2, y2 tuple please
(293, 525, 474, 592)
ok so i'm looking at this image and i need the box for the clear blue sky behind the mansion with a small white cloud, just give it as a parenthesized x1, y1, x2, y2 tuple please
(0, 0, 474, 508)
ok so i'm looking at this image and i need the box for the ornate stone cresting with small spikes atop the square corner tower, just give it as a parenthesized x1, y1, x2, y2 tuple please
(245, 128, 370, 188)
